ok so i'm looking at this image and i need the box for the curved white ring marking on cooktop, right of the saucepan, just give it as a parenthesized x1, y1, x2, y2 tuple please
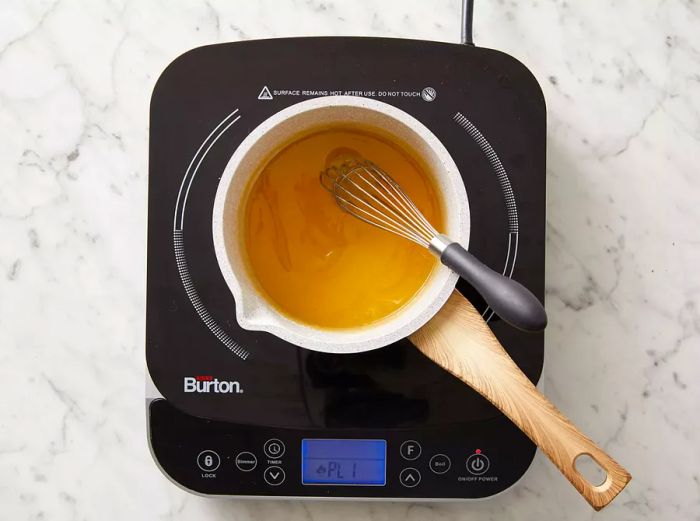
(452, 112, 518, 322)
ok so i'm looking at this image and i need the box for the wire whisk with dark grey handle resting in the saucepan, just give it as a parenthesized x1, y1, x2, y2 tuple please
(321, 158, 547, 331)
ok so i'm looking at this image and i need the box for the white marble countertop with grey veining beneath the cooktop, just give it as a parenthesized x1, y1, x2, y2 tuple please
(0, 0, 700, 521)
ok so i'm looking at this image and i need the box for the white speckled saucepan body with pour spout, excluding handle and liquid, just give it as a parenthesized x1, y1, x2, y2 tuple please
(213, 96, 469, 353)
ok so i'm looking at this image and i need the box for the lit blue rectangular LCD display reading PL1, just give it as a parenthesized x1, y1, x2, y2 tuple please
(301, 440, 386, 486)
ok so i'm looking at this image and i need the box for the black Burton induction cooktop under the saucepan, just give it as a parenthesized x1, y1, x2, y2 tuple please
(146, 29, 545, 499)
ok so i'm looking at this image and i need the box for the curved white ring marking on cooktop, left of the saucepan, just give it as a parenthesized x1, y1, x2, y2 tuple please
(173, 109, 250, 360)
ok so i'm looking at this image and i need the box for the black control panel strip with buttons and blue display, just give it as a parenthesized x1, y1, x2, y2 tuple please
(149, 400, 535, 499)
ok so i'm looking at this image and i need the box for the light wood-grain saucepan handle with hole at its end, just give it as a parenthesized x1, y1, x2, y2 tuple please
(410, 291, 632, 510)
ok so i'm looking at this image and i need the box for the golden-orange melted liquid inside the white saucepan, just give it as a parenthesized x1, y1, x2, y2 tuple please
(242, 127, 442, 329)
